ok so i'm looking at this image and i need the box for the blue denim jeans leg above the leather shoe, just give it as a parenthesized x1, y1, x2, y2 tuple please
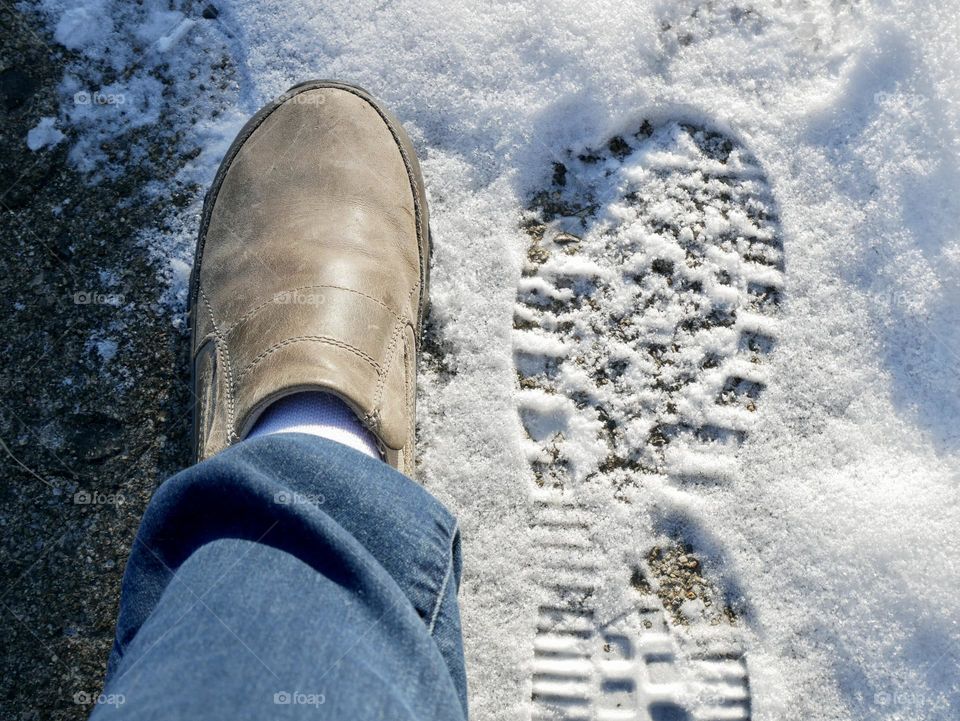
(91, 434, 467, 721)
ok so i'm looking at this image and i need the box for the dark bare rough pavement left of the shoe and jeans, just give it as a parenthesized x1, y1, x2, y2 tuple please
(0, 4, 197, 721)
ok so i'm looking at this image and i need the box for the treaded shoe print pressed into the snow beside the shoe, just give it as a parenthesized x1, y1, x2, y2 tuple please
(514, 123, 784, 721)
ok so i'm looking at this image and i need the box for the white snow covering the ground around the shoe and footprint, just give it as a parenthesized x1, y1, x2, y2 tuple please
(24, 0, 960, 719)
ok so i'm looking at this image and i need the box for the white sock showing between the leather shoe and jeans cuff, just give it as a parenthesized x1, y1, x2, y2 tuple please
(247, 391, 381, 460)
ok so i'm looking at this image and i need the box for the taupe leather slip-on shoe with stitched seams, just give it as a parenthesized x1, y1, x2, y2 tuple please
(190, 80, 430, 476)
